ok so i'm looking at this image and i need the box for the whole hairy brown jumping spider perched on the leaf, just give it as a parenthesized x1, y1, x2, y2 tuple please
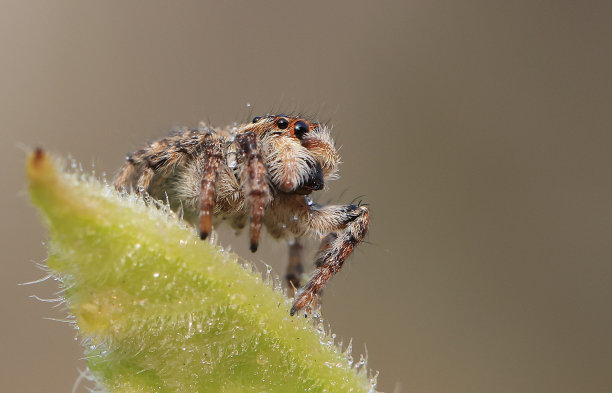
(115, 115, 370, 315)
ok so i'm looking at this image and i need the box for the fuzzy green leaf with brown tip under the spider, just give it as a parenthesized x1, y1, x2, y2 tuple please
(27, 150, 375, 392)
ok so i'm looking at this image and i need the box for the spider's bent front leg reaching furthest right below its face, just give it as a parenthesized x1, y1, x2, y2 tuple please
(291, 205, 370, 315)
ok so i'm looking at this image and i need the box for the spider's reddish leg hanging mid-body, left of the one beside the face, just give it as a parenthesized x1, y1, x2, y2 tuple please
(200, 134, 223, 240)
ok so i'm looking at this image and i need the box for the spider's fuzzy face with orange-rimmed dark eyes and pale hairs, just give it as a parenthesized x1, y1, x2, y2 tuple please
(247, 115, 339, 195)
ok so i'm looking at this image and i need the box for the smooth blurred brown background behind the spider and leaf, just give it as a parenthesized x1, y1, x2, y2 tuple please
(0, 0, 612, 393)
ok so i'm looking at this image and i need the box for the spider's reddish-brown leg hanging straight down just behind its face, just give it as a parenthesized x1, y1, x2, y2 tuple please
(237, 132, 270, 252)
